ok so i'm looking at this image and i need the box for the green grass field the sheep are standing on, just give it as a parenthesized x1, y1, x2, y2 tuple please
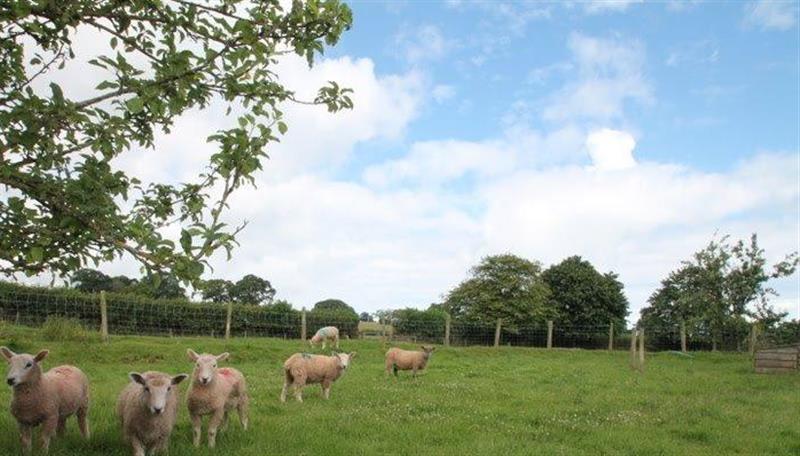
(0, 326, 800, 456)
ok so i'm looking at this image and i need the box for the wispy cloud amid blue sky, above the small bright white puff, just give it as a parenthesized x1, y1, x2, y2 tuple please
(543, 33, 654, 121)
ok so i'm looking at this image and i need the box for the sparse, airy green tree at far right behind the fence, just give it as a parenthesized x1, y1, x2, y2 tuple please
(641, 234, 798, 348)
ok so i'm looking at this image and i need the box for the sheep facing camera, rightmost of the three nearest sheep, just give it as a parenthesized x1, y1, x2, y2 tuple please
(186, 349, 250, 448)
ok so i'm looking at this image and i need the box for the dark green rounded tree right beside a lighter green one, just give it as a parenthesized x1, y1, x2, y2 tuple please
(542, 256, 628, 328)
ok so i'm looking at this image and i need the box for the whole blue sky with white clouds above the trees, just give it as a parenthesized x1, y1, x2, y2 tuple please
(15, 1, 800, 321)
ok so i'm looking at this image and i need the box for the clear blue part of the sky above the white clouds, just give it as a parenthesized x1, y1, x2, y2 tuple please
(329, 1, 800, 170)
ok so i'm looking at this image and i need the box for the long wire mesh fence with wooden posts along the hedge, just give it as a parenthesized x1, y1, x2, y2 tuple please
(0, 284, 800, 351)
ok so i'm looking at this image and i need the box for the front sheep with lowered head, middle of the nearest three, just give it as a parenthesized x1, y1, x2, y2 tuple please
(117, 371, 188, 456)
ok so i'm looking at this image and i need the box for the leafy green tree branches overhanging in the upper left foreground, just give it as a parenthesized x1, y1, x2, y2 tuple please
(0, 0, 352, 281)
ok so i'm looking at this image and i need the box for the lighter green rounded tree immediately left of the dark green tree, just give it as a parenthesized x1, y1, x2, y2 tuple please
(444, 254, 555, 326)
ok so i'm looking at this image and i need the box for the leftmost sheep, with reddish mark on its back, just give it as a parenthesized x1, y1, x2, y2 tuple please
(0, 347, 89, 453)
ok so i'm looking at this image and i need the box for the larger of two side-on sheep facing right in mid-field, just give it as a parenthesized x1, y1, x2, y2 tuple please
(281, 352, 356, 402)
